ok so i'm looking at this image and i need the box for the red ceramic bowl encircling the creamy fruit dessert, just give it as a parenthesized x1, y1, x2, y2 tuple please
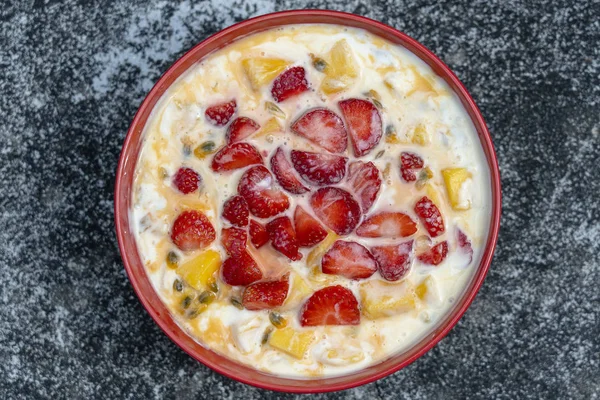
(115, 10, 501, 393)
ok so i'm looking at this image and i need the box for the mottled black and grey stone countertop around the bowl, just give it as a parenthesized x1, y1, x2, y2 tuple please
(0, 0, 600, 399)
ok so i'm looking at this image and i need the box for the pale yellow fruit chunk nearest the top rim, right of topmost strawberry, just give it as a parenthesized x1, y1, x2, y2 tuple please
(321, 39, 359, 94)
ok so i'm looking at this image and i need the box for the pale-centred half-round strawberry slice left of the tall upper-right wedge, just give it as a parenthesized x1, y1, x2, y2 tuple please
(291, 108, 348, 153)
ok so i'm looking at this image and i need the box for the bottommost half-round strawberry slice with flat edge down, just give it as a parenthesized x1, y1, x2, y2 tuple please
(300, 285, 360, 326)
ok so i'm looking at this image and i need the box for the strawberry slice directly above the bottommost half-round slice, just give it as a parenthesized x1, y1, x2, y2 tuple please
(321, 240, 377, 279)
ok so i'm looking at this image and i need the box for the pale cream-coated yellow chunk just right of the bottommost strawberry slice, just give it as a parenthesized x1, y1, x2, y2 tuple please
(359, 280, 417, 319)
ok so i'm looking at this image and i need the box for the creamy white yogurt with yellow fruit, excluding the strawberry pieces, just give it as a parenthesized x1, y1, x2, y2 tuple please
(130, 25, 491, 378)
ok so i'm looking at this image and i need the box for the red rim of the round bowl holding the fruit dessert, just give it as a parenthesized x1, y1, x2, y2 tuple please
(114, 9, 502, 393)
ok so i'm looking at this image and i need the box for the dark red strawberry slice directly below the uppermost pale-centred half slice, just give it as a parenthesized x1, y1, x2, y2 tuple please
(291, 150, 348, 186)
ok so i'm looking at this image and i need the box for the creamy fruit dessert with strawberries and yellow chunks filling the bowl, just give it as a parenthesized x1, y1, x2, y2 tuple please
(131, 25, 491, 378)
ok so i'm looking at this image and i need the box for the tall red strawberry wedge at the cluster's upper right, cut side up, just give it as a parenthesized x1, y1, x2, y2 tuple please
(339, 99, 383, 157)
